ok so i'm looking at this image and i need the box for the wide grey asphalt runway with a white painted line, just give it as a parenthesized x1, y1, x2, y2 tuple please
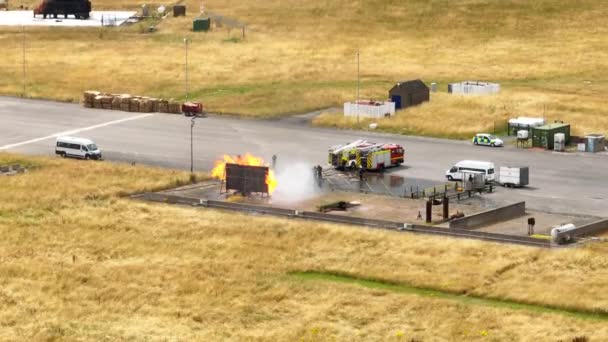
(0, 97, 608, 216)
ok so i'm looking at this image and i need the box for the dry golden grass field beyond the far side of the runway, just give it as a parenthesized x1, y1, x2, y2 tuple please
(0, 0, 608, 137)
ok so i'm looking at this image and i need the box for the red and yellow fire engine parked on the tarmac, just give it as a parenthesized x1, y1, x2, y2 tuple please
(328, 140, 405, 170)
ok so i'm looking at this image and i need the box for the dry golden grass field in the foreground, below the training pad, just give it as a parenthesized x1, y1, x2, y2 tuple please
(0, 154, 608, 341)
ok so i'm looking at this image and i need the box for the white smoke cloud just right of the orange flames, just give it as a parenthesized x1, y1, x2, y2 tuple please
(272, 163, 319, 202)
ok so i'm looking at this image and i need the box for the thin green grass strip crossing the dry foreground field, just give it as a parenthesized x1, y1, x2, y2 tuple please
(289, 271, 608, 321)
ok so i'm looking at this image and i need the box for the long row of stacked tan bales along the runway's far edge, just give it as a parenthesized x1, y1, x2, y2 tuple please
(82, 90, 182, 114)
